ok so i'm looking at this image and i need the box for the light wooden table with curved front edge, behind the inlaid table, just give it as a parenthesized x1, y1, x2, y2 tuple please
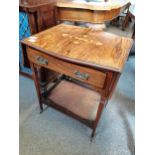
(55, 0, 129, 24)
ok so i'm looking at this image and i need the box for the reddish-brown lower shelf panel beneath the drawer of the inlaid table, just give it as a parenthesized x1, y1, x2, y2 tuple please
(48, 80, 101, 121)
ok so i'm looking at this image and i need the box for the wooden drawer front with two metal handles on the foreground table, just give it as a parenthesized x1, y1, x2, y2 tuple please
(28, 48, 106, 88)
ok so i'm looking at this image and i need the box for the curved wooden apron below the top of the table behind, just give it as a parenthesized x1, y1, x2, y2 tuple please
(56, 7, 121, 24)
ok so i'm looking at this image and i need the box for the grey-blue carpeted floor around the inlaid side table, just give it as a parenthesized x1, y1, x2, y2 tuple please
(19, 22, 135, 155)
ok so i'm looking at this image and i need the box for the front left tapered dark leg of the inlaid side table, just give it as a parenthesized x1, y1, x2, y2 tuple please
(30, 63, 43, 113)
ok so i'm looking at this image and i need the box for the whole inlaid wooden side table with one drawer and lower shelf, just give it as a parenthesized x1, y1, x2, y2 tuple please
(22, 24, 133, 137)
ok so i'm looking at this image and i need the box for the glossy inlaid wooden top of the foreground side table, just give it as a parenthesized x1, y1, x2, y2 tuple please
(21, 24, 133, 72)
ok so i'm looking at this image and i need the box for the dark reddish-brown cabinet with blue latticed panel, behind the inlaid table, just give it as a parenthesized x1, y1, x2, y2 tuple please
(19, 0, 56, 84)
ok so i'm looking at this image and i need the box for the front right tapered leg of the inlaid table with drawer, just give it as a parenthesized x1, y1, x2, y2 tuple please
(91, 99, 106, 138)
